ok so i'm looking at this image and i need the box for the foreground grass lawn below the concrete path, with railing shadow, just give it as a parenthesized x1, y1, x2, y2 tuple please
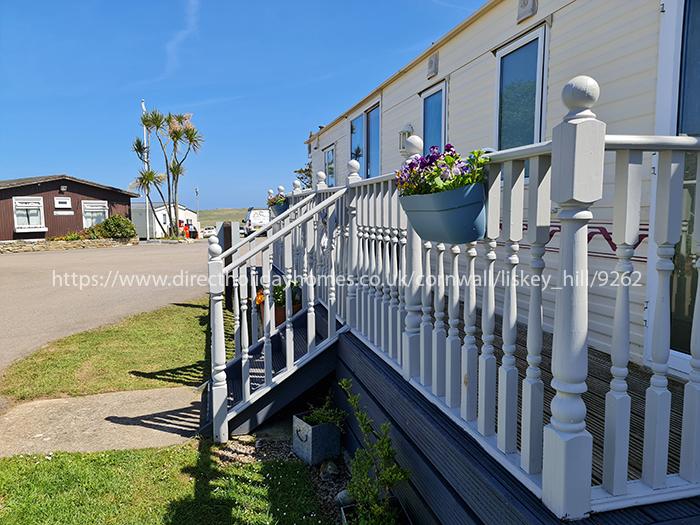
(0, 439, 332, 525)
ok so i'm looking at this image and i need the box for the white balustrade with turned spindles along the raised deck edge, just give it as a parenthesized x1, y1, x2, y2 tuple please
(212, 77, 700, 519)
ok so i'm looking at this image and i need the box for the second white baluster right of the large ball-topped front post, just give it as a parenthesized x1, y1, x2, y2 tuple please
(642, 151, 685, 489)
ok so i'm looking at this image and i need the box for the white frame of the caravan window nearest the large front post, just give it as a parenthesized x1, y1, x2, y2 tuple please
(493, 24, 549, 151)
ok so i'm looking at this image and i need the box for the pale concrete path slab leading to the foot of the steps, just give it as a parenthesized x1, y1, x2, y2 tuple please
(0, 387, 201, 457)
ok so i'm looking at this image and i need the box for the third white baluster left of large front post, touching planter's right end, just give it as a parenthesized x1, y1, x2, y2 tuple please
(478, 158, 501, 436)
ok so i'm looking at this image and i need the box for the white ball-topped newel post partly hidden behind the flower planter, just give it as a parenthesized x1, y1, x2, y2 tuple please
(401, 135, 423, 380)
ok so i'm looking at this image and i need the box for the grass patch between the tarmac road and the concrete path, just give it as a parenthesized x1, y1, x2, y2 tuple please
(0, 298, 234, 401)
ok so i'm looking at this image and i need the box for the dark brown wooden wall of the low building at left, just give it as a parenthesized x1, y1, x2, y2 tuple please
(0, 180, 131, 241)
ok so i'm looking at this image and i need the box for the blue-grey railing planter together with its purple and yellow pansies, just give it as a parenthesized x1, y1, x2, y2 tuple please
(396, 144, 488, 244)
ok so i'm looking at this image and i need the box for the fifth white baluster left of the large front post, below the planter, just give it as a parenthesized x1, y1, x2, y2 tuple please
(446, 244, 462, 408)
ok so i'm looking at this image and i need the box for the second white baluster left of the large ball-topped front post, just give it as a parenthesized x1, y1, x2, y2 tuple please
(498, 161, 525, 454)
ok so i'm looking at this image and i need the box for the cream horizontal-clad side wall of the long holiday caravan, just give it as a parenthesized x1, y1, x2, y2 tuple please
(312, 0, 661, 363)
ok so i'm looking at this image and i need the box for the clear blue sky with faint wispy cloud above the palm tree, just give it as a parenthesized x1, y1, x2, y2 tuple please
(0, 0, 483, 209)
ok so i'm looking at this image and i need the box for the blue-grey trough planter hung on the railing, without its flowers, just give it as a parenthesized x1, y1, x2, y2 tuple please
(399, 183, 486, 244)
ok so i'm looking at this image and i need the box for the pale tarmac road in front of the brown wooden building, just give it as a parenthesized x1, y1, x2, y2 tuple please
(0, 241, 208, 370)
